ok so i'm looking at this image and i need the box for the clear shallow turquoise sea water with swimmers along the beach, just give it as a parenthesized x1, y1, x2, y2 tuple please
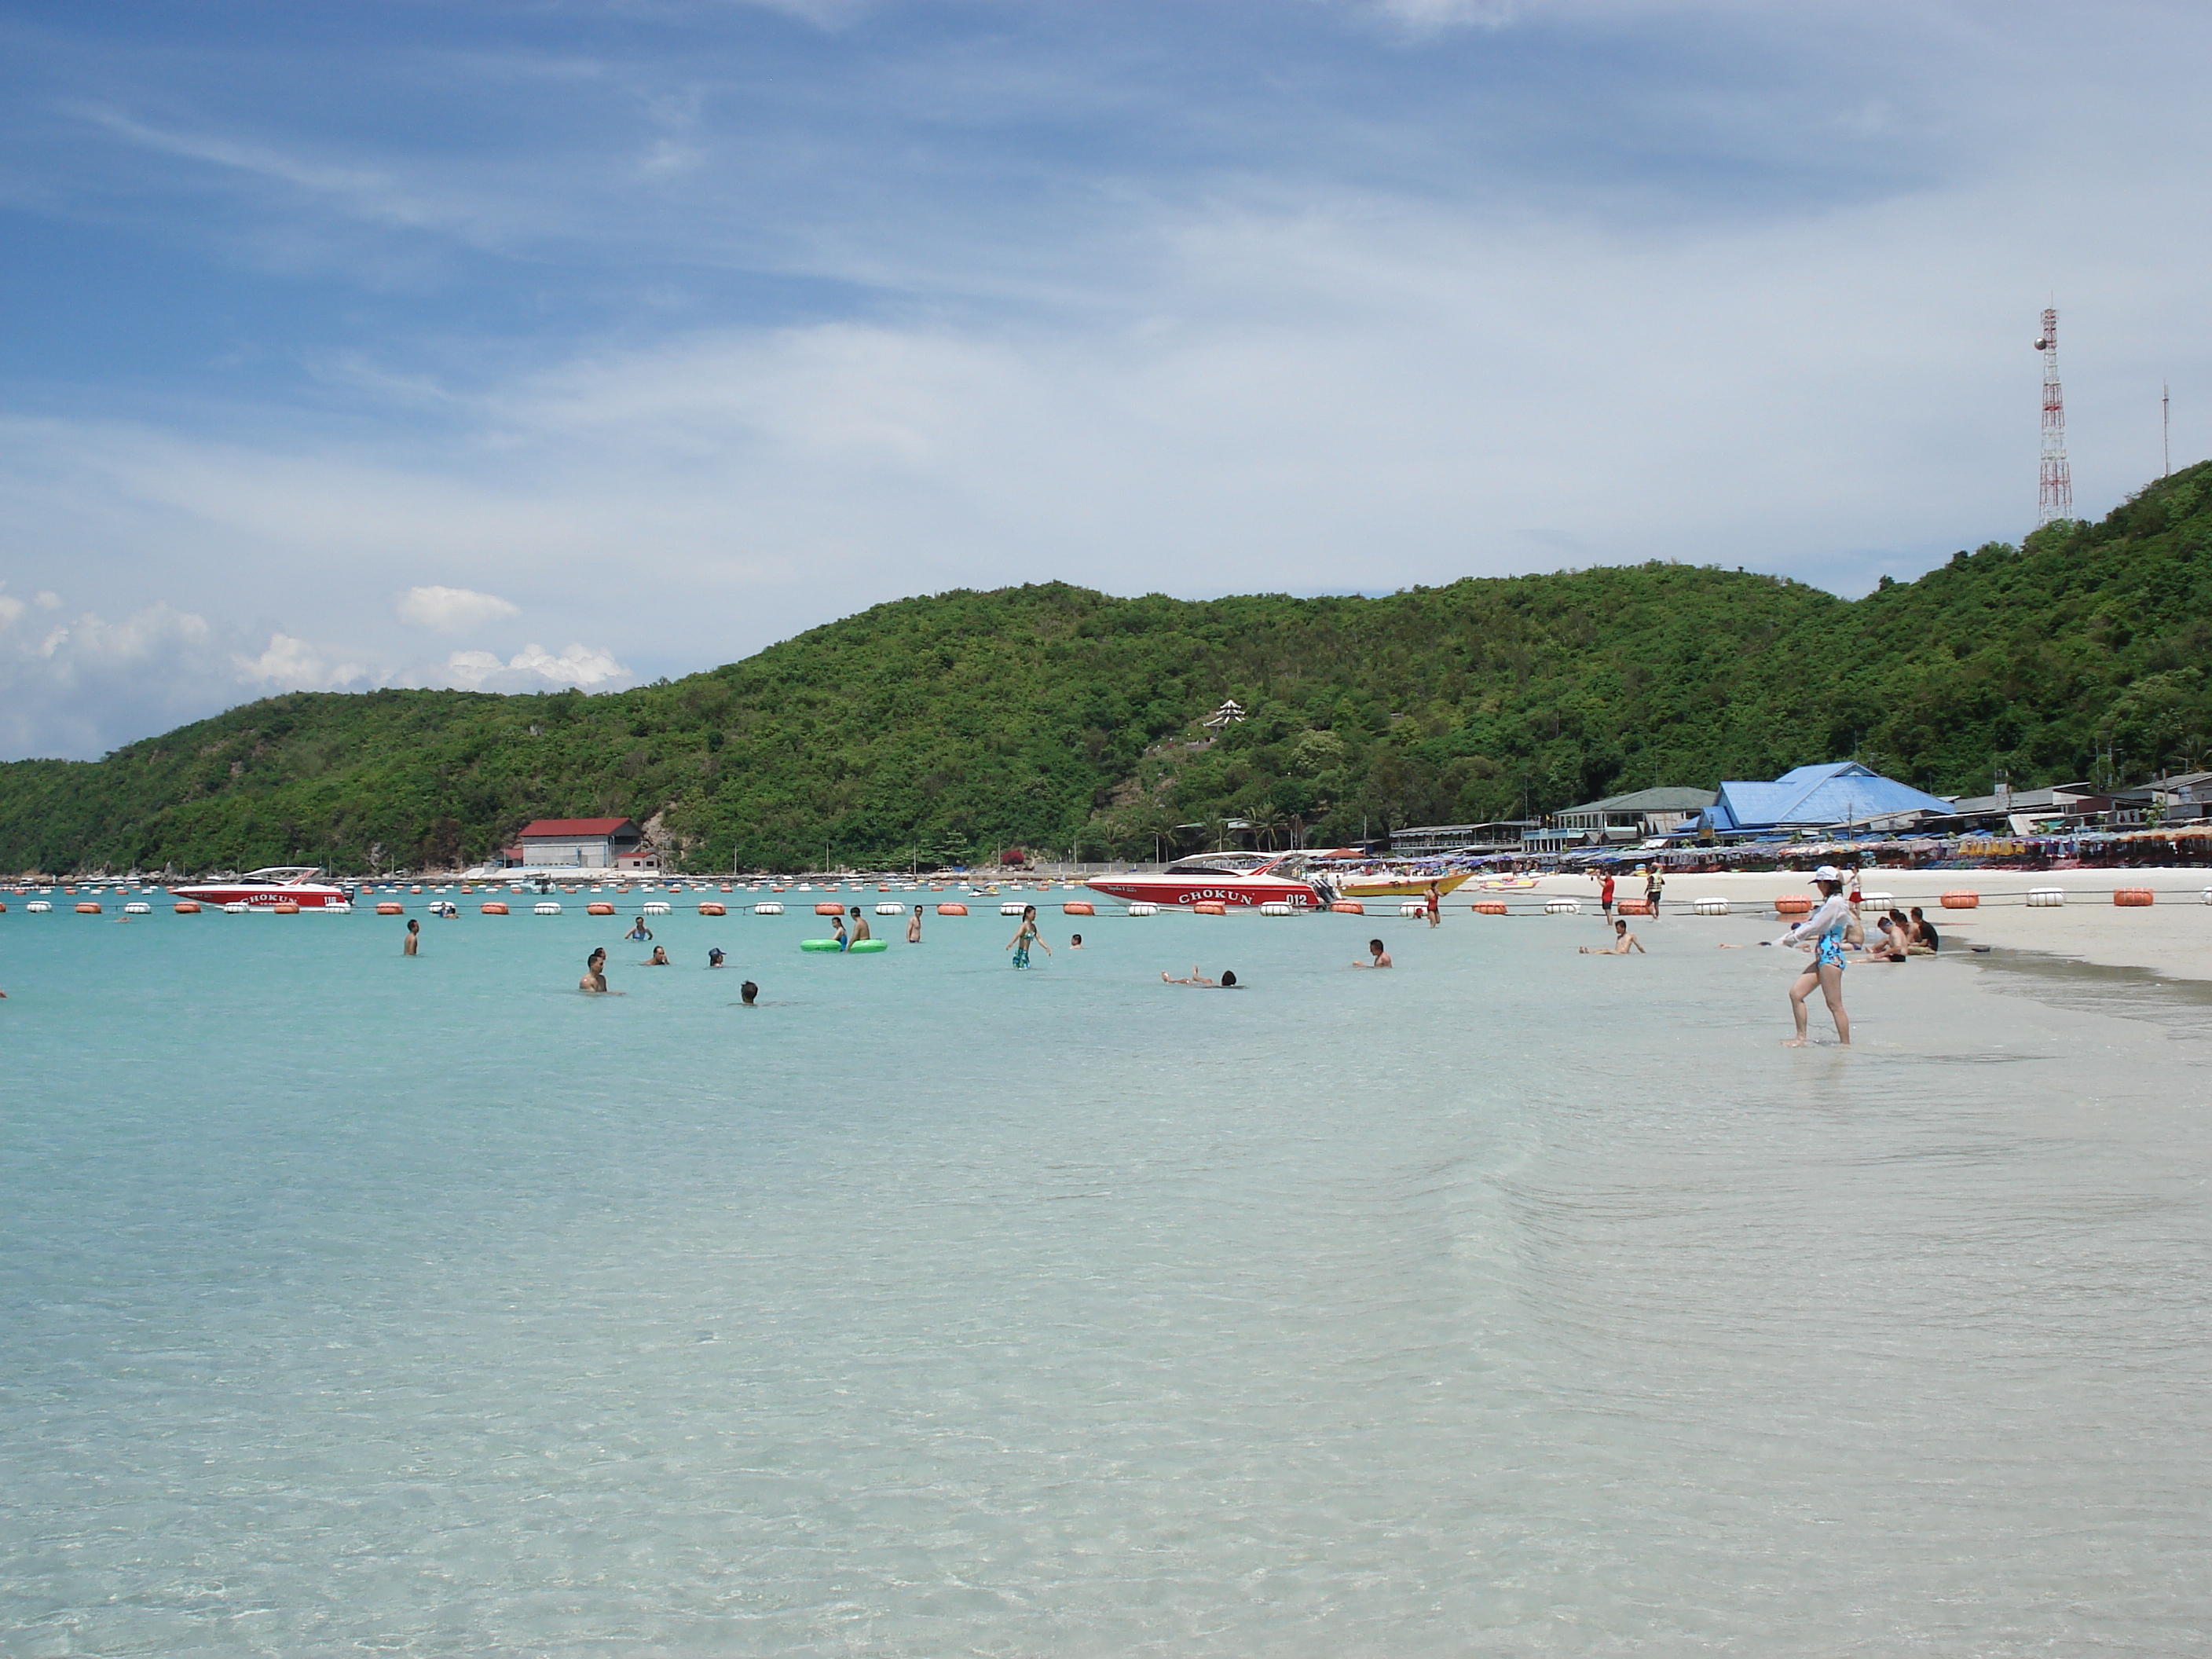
(0, 894, 2212, 1657)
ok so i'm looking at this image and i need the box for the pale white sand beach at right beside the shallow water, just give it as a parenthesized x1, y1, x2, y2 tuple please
(1503, 867, 2212, 980)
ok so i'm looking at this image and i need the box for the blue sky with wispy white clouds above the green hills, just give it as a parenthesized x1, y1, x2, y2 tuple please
(0, 0, 2212, 759)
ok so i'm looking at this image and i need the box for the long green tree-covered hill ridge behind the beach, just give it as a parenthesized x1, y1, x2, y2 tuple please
(0, 463, 2212, 872)
